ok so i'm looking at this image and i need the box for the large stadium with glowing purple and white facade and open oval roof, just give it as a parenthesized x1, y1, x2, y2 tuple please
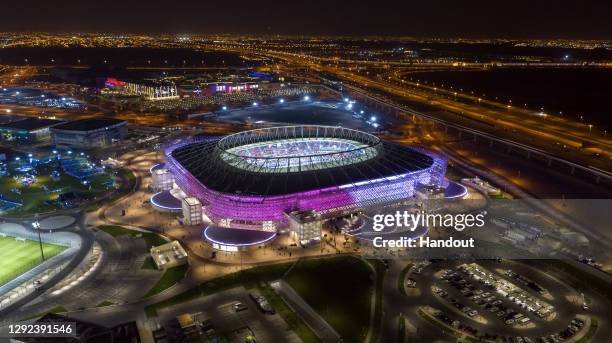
(160, 125, 456, 250)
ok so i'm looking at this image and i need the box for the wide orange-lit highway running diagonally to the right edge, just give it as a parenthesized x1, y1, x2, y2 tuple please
(221, 47, 612, 171)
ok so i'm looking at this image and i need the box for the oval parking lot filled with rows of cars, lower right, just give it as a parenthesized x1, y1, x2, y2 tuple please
(405, 260, 590, 343)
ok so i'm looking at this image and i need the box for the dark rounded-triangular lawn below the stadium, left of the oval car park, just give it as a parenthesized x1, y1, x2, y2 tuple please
(285, 256, 374, 342)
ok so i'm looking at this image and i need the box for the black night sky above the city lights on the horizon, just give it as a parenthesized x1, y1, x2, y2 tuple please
(0, 0, 612, 39)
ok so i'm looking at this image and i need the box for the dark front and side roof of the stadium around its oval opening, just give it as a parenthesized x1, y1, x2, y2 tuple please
(171, 140, 434, 196)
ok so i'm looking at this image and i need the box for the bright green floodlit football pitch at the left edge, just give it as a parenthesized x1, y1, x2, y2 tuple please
(0, 236, 66, 286)
